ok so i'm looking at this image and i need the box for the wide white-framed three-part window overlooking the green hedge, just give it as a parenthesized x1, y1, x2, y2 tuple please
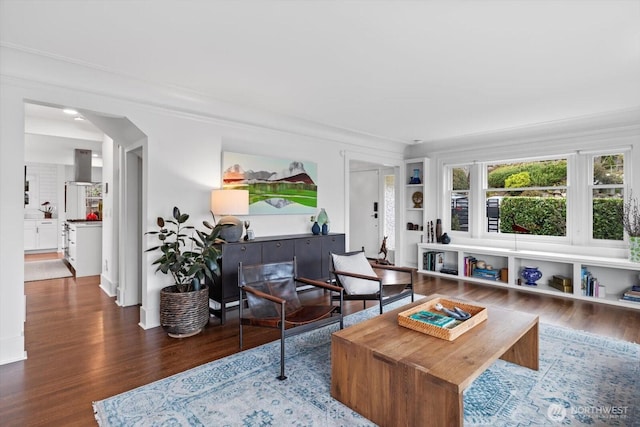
(442, 147, 631, 247)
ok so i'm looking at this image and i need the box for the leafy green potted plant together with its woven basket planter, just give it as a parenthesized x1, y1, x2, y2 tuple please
(145, 207, 230, 338)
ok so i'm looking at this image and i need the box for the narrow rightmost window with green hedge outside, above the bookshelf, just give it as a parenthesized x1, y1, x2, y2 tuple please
(590, 153, 624, 240)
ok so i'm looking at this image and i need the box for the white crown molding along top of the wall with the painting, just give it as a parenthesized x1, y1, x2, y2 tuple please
(0, 42, 407, 154)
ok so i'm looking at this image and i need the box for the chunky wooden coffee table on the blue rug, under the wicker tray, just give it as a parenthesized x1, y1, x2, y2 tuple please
(331, 295, 538, 427)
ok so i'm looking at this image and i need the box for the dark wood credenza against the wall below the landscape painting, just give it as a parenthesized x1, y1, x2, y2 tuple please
(209, 233, 345, 323)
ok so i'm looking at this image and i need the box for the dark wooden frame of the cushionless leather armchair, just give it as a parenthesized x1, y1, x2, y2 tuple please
(238, 258, 344, 380)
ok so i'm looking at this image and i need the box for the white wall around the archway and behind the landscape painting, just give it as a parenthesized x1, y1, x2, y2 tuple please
(0, 47, 404, 364)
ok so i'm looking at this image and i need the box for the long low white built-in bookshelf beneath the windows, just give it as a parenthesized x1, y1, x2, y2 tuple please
(416, 243, 640, 310)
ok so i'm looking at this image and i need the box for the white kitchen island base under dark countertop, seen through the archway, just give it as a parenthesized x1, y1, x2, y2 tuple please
(65, 221, 102, 277)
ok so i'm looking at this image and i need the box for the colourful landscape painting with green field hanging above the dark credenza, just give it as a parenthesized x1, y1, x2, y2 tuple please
(222, 152, 318, 215)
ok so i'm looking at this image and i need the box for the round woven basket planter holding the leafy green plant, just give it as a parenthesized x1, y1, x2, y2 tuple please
(160, 285, 209, 338)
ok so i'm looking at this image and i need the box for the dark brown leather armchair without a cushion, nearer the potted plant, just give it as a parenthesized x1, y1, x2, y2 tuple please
(238, 258, 344, 380)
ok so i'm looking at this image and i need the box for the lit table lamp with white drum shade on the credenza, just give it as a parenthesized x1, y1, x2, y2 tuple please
(211, 189, 249, 243)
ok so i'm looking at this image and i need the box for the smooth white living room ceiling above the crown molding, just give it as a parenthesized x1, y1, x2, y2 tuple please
(0, 0, 640, 143)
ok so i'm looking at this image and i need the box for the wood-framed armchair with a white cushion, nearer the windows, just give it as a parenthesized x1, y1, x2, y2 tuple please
(329, 249, 416, 314)
